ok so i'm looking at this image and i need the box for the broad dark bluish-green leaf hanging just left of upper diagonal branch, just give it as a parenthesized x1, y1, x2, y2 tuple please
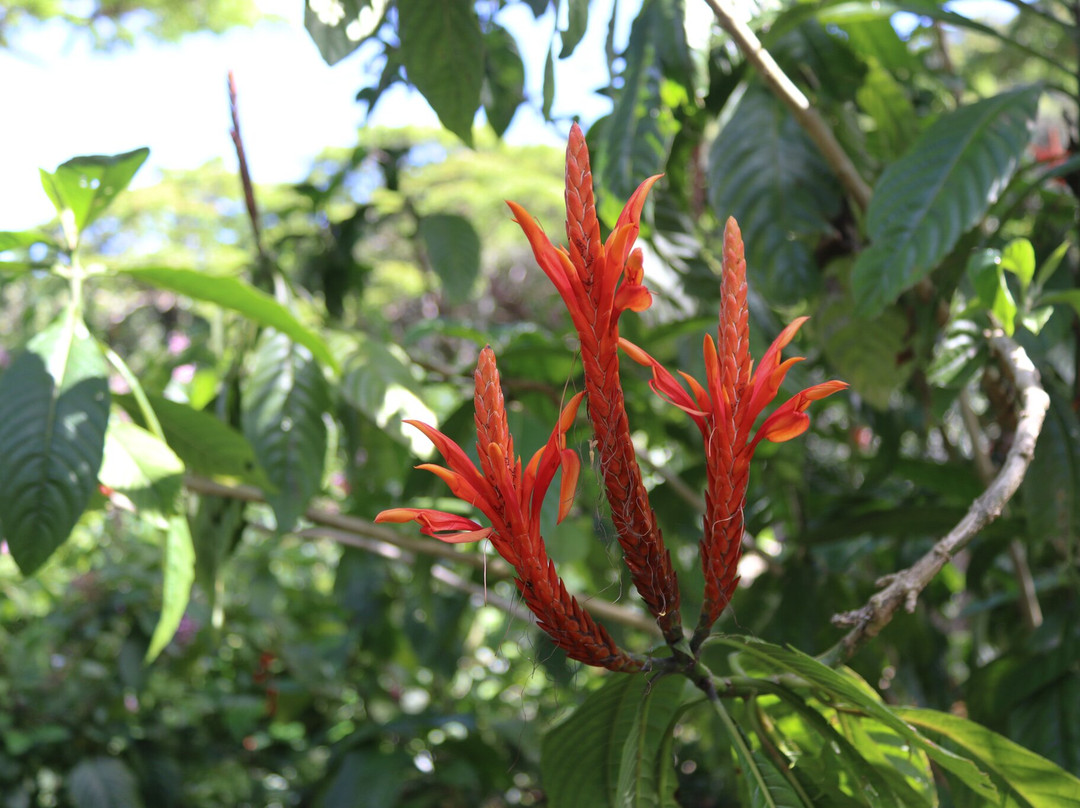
(708, 87, 841, 304)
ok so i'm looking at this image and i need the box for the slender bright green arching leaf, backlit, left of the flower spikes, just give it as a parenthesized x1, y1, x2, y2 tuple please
(118, 267, 338, 371)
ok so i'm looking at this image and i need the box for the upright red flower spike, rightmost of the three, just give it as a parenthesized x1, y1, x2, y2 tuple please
(620, 219, 848, 650)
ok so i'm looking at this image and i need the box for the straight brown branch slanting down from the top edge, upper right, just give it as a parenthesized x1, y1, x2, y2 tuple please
(705, 0, 873, 211)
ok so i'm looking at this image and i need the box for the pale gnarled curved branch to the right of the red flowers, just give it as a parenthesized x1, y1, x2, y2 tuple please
(820, 332, 1050, 664)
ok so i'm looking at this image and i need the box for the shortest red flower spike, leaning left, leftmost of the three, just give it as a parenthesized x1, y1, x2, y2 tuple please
(375, 348, 646, 672)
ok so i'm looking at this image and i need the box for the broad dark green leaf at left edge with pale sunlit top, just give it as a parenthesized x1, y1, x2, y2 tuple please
(0, 311, 109, 575)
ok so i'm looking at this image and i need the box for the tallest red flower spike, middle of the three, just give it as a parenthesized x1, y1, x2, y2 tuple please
(508, 124, 684, 645)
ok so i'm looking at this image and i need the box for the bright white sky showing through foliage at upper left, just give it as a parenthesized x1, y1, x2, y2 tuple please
(0, 0, 640, 230)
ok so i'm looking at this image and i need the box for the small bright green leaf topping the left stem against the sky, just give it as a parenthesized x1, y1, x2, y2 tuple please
(41, 148, 150, 248)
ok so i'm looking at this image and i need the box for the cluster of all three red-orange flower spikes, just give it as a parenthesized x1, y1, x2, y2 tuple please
(376, 124, 847, 672)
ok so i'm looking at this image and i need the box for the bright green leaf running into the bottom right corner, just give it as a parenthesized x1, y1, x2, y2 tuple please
(895, 708, 1080, 808)
